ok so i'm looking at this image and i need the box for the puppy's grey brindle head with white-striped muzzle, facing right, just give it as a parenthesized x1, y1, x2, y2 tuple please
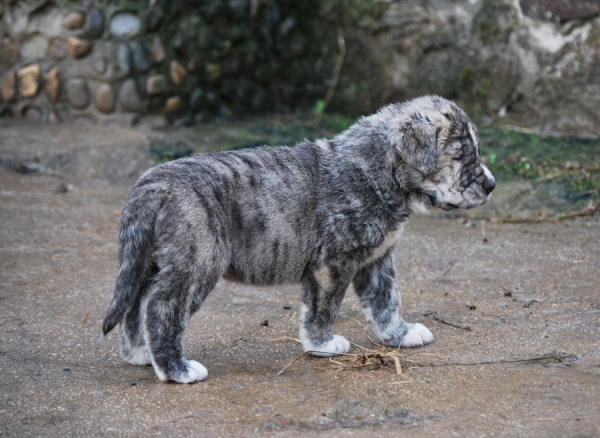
(387, 96, 496, 210)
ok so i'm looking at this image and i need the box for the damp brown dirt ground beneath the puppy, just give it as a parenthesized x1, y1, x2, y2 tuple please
(0, 124, 600, 437)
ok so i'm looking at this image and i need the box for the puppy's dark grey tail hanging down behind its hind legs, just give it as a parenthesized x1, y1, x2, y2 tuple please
(102, 186, 160, 336)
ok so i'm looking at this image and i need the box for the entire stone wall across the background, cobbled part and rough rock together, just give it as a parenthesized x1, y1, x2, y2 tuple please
(0, 0, 600, 135)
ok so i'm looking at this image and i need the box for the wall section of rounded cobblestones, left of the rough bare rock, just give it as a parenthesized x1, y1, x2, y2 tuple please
(0, 0, 350, 125)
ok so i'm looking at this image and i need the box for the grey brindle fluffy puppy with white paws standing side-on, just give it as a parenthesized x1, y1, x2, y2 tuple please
(102, 96, 495, 383)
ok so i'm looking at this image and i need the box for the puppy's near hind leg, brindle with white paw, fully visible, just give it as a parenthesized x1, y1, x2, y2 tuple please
(143, 221, 229, 383)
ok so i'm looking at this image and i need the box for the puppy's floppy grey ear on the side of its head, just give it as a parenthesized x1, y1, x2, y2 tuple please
(388, 118, 438, 175)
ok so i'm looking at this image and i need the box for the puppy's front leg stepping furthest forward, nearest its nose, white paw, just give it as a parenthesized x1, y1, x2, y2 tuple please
(353, 253, 433, 348)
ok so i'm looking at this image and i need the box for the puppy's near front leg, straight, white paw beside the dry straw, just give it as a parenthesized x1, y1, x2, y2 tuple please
(300, 268, 350, 356)
